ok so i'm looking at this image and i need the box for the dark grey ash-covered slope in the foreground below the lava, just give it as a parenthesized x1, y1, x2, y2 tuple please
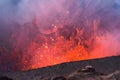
(0, 56, 120, 80)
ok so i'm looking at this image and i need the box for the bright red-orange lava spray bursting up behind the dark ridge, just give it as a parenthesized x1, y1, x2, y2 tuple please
(10, 18, 114, 70)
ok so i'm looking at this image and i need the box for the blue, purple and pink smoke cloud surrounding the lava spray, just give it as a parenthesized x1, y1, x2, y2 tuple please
(0, 0, 120, 70)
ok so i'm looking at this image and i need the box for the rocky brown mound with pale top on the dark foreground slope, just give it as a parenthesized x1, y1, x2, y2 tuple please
(68, 65, 103, 80)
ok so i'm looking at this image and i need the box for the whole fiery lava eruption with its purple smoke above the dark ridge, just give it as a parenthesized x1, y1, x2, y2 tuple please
(0, 0, 120, 71)
